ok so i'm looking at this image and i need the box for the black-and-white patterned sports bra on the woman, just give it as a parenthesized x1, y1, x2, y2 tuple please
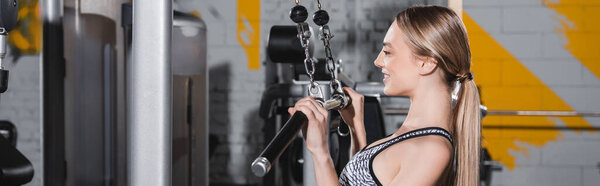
(339, 127, 452, 186)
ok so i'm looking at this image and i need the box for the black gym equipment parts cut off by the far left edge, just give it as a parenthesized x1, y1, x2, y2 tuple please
(0, 0, 33, 186)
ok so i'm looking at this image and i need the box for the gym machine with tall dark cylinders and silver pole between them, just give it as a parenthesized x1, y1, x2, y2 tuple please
(36, 0, 208, 186)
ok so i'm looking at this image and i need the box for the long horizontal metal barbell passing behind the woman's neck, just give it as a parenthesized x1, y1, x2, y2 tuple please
(384, 108, 600, 117)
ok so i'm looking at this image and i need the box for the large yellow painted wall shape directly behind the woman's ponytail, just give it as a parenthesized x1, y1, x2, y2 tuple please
(463, 13, 590, 169)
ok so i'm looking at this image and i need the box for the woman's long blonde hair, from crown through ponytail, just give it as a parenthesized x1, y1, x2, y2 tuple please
(396, 6, 481, 186)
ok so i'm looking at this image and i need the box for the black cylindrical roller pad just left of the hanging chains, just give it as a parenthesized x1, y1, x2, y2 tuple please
(267, 25, 313, 63)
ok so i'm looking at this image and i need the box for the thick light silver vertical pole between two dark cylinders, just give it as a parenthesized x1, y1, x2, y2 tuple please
(127, 0, 173, 186)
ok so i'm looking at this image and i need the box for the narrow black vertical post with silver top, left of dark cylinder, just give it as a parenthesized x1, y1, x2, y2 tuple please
(41, 0, 66, 186)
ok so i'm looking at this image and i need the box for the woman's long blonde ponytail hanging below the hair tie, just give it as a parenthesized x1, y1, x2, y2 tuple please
(453, 79, 481, 186)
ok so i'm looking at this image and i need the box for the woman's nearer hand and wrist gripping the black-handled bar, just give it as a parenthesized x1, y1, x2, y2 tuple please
(288, 96, 329, 156)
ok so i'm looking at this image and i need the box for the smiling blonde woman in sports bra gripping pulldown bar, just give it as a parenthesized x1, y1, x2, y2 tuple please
(288, 6, 480, 186)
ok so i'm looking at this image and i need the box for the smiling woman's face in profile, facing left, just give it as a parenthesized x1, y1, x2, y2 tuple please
(374, 21, 419, 96)
